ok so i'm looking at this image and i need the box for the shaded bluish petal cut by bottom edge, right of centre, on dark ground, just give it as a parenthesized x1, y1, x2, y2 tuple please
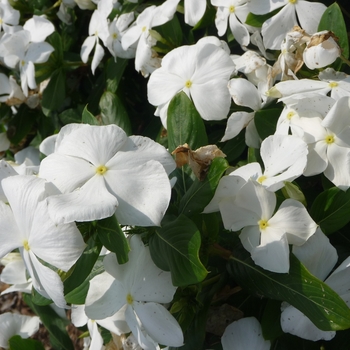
(221, 317, 271, 350)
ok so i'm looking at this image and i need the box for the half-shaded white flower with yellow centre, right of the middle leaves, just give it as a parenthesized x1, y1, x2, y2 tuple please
(212, 177, 317, 273)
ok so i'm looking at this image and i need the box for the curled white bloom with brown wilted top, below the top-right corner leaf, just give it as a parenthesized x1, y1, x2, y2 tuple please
(303, 31, 341, 69)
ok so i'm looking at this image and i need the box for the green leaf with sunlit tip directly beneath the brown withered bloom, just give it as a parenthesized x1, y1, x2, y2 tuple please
(179, 158, 229, 216)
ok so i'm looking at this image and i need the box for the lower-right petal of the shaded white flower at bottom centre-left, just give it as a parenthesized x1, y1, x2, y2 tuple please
(134, 303, 184, 347)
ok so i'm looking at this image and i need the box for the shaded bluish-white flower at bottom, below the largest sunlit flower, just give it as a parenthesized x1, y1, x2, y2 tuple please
(85, 235, 183, 350)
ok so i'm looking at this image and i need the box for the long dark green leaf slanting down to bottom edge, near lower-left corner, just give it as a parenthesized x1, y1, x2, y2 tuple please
(22, 293, 74, 350)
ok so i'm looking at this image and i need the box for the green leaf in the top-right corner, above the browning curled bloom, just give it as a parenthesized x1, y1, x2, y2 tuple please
(318, 2, 349, 58)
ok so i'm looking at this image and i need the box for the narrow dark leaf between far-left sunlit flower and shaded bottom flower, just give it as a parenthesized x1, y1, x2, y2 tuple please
(64, 236, 102, 294)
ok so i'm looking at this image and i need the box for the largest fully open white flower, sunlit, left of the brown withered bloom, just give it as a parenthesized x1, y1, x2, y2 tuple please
(39, 124, 175, 226)
